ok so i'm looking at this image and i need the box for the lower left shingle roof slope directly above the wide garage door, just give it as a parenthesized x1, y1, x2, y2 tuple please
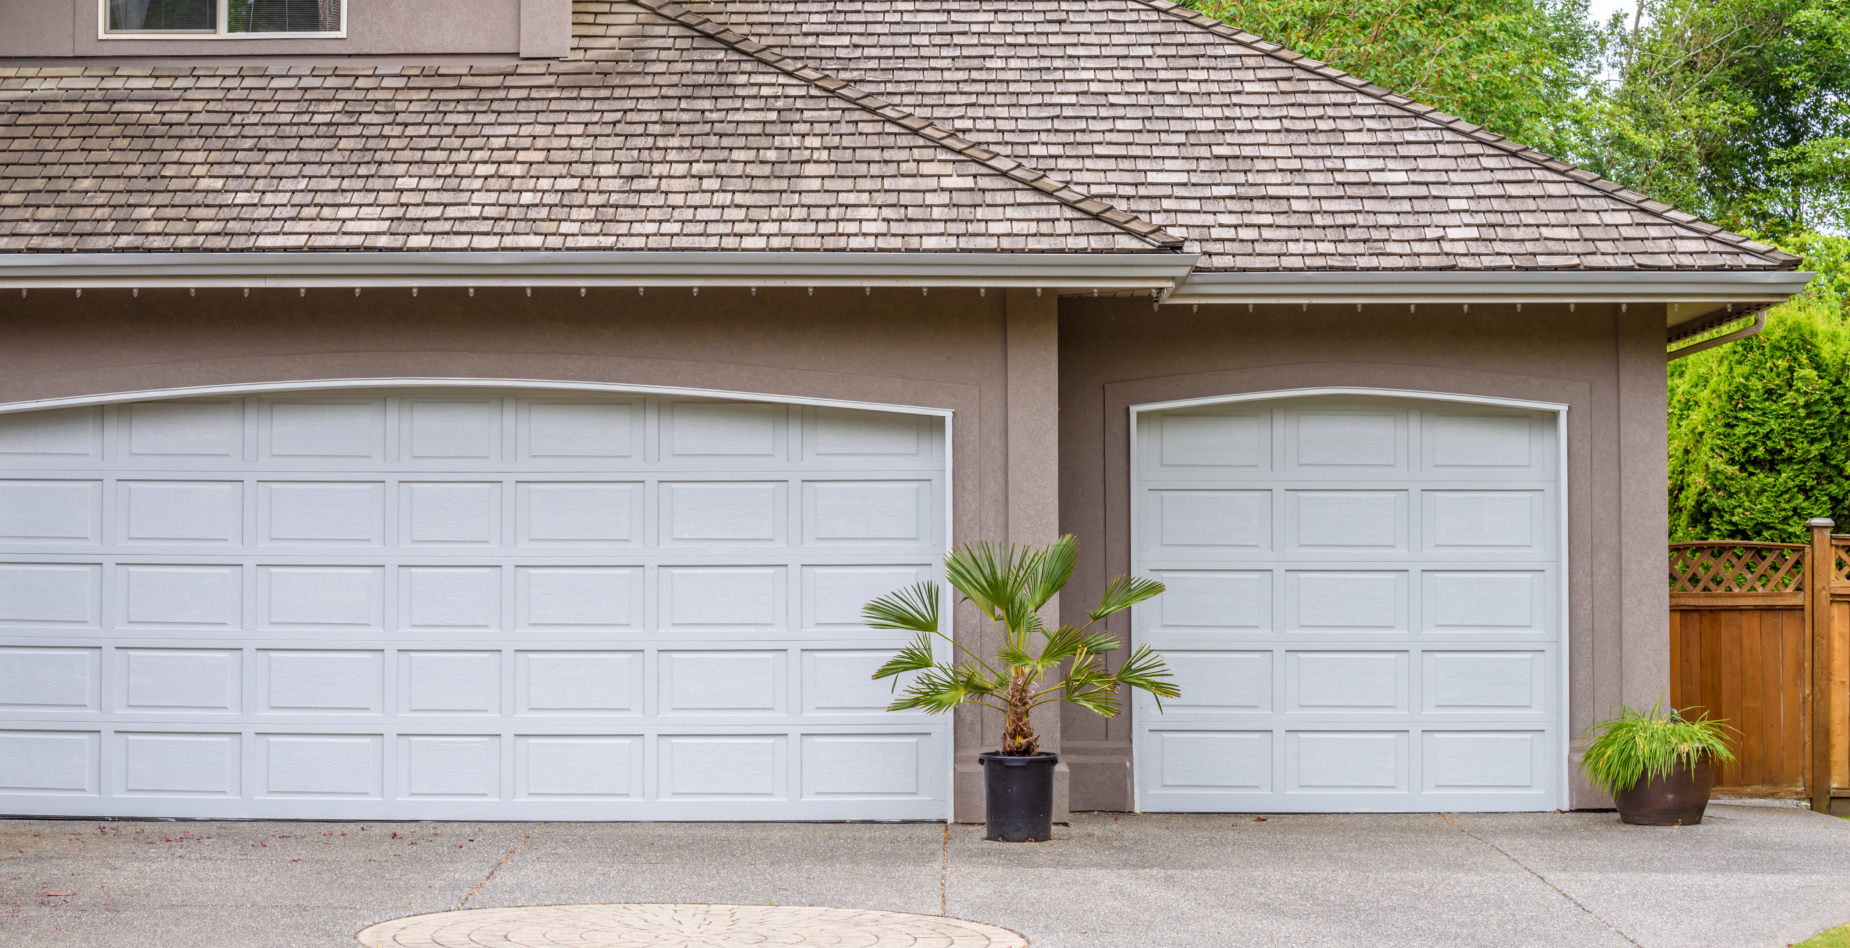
(0, 48, 1162, 252)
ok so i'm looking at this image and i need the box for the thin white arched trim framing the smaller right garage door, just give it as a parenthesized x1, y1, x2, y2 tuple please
(1129, 387, 1574, 813)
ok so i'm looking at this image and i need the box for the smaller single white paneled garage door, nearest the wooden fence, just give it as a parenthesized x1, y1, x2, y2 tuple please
(1132, 396, 1561, 813)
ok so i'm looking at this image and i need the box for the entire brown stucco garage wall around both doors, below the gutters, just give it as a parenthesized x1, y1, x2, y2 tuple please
(0, 287, 1669, 820)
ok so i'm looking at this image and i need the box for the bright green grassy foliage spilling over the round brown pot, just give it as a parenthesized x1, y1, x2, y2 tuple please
(1580, 698, 1733, 796)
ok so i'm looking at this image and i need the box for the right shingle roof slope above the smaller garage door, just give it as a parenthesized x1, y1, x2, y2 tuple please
(643, 0, 1796, 270)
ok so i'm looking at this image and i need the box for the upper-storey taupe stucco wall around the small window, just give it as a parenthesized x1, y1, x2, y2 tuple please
(0, 0, 521, 57)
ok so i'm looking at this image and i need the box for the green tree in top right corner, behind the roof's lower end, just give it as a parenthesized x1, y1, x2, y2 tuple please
(1567, 0, 1850, 239)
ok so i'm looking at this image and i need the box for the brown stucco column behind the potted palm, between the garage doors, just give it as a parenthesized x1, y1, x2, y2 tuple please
(956, 289, 1067, 822)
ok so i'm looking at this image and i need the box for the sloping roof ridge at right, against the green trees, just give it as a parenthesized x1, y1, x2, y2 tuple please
(1130, 0, 1804, 270)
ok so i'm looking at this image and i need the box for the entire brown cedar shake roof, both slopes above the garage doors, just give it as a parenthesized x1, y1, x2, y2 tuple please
(0, 0, 1796, 270)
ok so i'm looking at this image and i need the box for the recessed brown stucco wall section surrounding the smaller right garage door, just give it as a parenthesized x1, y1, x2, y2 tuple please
(1060, 298, 1669, 809)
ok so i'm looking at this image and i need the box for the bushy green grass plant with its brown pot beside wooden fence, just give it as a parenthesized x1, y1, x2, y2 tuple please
(1580, 698, 1733, 826)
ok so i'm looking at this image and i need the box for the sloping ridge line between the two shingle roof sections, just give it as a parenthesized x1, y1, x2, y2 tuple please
(629, 0, 1184, 250)
